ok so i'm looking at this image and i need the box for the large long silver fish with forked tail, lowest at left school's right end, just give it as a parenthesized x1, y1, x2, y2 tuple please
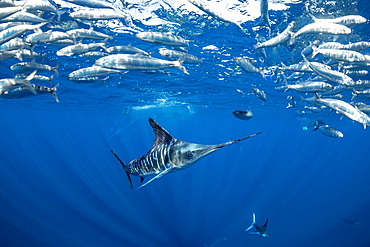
(95, 54, 189, 74)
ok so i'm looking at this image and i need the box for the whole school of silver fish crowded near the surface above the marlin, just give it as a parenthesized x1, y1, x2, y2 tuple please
(0, 0, 370, 138)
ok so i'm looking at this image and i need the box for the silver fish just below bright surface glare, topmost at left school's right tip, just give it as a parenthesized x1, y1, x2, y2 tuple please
(136, 32, 189, 47)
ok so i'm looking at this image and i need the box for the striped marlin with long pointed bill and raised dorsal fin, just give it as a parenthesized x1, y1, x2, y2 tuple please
(110, 118, 262, 189)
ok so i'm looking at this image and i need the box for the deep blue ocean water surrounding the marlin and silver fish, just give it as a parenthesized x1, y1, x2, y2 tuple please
(0, 0, 370, 247)
